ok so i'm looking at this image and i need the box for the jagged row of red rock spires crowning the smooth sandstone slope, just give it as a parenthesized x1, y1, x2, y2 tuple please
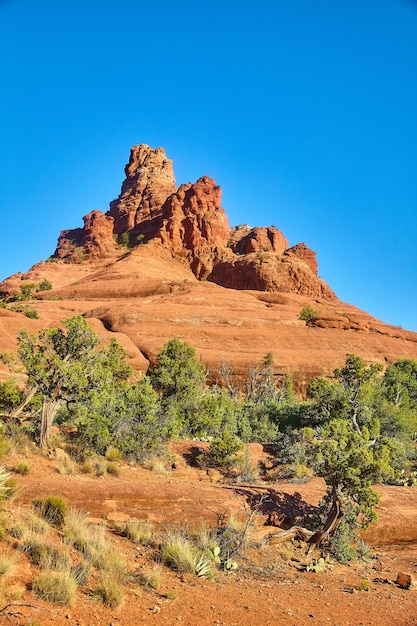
(55, 144, 335, 299)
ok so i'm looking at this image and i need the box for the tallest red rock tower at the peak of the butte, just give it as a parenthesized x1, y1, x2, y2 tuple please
(108, 144, 177, 238)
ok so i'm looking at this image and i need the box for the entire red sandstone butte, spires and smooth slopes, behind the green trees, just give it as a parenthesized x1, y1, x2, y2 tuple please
(0, 144, 417, 393)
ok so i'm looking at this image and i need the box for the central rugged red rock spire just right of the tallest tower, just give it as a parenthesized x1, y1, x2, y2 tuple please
(157, 176, 230, 278)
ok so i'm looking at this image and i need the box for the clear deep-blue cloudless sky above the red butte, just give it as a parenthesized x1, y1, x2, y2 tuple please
(0, 0, 417, 331)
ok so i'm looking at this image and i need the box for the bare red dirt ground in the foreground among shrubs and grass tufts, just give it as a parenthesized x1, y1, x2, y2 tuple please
(0, 442, 417, 626)
